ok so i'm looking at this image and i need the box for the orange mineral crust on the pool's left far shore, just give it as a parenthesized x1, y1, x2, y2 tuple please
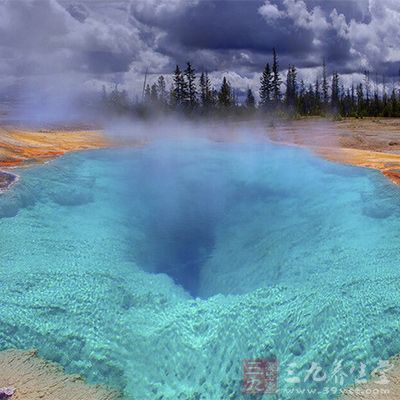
(0, 127, 111, 168)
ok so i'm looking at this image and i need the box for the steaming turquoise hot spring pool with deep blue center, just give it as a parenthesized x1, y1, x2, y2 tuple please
(0, 138, 400, 400)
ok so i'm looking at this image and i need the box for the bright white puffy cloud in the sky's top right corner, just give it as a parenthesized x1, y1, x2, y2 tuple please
(258, 0, 400, 69)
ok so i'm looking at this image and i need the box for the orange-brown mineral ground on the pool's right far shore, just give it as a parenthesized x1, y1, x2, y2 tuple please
(267, 118, 400, 184)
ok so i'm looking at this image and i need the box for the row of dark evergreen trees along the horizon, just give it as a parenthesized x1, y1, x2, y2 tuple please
(102, 49, 400, 117)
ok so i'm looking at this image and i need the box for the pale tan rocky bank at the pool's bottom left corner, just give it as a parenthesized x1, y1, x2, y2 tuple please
(0, 350, 121, 400)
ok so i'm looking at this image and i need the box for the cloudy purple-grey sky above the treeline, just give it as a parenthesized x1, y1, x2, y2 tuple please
(0, 0, 400, 100)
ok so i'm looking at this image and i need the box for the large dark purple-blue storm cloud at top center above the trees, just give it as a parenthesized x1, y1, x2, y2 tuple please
(132, 0, 312, 53)
